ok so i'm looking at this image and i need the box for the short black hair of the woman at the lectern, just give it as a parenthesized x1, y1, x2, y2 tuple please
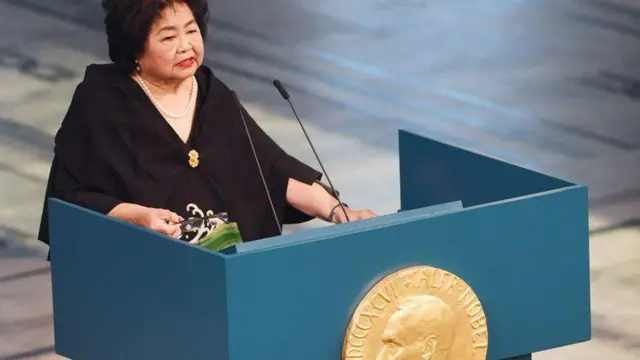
(102, 0, 209, 74)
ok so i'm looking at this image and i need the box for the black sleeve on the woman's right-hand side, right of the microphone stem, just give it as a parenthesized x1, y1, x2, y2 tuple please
(238, 104, 322, 224)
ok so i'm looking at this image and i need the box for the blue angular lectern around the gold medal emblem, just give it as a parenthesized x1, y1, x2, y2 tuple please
(50, 131, 591, 360)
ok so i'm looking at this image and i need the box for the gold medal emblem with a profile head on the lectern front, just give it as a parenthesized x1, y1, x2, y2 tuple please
(342, 266, 489, 360)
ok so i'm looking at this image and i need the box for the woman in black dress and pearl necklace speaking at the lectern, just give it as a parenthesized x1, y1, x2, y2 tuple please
(40, 0, 375, 248)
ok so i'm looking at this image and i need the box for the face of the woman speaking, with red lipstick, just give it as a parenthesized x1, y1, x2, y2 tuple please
(138, 3, 204, 81)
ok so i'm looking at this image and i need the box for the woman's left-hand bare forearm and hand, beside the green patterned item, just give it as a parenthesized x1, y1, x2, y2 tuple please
(108, 203, 184, 238)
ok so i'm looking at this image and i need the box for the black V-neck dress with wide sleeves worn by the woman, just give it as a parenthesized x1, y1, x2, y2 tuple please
(39, 64, 321, 248)
